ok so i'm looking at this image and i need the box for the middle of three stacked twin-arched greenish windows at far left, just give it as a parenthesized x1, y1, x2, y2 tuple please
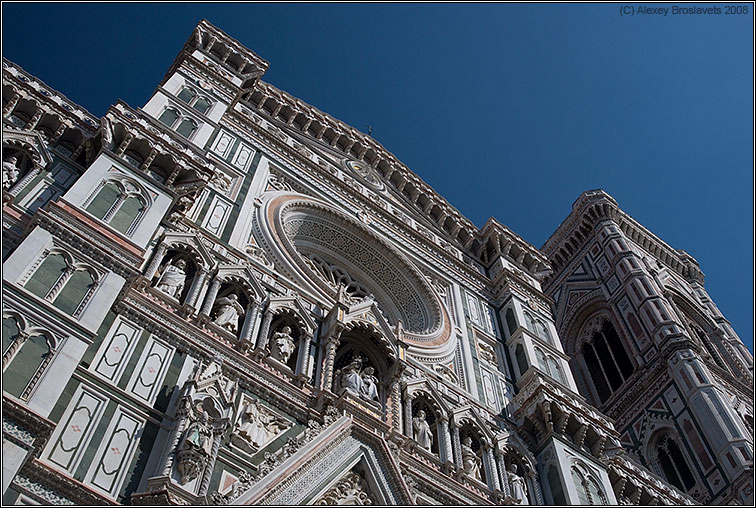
(24, 252, 98, 317)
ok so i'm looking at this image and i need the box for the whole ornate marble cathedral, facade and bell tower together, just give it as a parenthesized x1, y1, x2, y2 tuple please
(2, 21, 754, 505)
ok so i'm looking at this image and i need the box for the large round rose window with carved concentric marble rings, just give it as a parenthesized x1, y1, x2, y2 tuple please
(255, 191, 454, 356)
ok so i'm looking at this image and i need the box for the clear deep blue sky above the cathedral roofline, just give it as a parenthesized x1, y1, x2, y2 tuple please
(2, 2, 754, 350)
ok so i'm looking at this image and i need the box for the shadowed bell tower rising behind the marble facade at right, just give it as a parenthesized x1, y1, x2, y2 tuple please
(542, 190, 753, 504)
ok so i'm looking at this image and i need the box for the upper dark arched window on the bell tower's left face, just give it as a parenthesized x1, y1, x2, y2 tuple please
(582, 321, 633, 402)
